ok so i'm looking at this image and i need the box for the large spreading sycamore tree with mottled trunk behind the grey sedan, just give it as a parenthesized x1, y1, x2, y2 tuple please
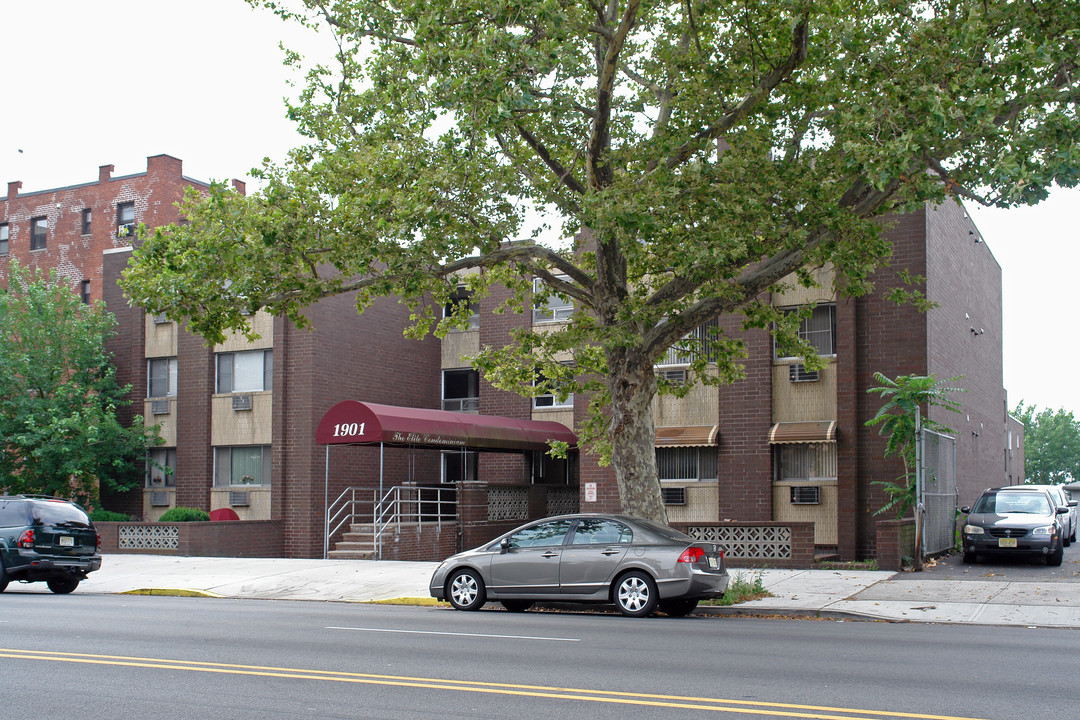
(123, 0, 1080, 519)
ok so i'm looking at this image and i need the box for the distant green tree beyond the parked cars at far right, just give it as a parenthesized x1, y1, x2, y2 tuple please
(1014, 400, 1080, 485)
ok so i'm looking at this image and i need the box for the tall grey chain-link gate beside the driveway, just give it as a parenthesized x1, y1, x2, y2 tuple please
(916, 429, 958, 555)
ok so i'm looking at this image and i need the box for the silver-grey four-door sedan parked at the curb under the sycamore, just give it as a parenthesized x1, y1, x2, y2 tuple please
(429, 514, 728, 617)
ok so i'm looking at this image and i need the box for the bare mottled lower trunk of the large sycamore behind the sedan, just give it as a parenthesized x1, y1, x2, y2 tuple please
(608, 355, 667, 525)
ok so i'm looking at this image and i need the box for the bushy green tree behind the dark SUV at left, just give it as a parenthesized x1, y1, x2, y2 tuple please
(0, 261, 161, 505)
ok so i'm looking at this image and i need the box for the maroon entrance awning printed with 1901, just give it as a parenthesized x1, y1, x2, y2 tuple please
(315, 400, 578, 451)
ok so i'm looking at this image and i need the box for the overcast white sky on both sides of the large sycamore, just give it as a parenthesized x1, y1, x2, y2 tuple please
(0, 0, 1080, 416)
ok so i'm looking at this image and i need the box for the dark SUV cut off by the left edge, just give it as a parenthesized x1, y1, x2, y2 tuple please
(0, 495, 102, 593)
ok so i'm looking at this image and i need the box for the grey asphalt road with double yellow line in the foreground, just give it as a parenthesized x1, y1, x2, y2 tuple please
(0, 593, 1080, 720)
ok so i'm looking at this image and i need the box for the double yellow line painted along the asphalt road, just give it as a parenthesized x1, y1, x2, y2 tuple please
(0, 648, 978, 720)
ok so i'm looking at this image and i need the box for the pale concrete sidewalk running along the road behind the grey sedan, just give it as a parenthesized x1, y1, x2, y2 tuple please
(14, 554, 1080, 628)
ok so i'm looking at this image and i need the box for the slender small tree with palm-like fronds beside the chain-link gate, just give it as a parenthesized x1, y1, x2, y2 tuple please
(866, 372, 964, 518)
